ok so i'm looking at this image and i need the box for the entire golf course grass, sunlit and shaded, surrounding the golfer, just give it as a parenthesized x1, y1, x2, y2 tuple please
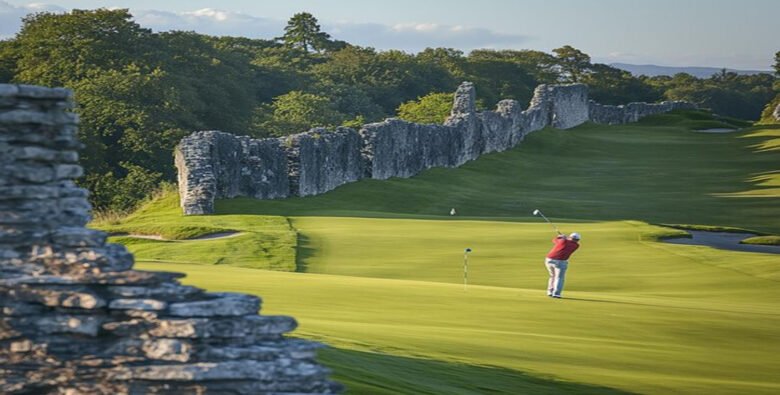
(105, 114, 780, 394)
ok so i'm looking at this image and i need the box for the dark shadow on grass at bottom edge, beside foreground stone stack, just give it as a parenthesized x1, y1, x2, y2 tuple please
(318, 348, 631, 395)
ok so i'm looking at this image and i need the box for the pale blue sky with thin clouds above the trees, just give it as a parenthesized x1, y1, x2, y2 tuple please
(0, 0, 780, 70)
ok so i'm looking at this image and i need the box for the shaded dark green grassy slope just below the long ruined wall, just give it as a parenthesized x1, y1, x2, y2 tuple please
(217, 115, 780, 233)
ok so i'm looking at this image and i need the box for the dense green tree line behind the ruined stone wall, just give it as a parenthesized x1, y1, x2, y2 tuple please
(0, 9, 776, 210)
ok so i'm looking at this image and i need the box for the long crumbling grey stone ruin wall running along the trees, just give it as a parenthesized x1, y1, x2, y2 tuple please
(176, 82, 695, 215)
